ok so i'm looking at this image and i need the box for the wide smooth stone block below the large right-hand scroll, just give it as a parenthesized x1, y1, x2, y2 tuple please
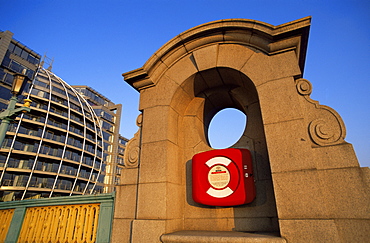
(273, 168, 370, 219)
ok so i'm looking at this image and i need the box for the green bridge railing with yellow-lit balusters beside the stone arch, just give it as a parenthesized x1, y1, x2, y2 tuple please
(0, 193, 115, 243)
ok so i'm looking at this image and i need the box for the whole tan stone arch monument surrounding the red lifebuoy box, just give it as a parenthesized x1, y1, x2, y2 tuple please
(113, 18, 369, 242)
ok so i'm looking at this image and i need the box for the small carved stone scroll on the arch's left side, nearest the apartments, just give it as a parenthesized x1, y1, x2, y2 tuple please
(124, 114, 143, 168)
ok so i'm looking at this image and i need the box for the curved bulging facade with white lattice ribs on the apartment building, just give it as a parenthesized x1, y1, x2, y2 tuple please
(0, 67, 105, 201)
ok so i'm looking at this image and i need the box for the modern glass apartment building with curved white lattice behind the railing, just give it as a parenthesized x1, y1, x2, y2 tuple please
(0, 31, 125, 201)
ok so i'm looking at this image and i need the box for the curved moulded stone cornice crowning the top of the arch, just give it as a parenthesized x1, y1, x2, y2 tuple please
(122, 17, 311, 91)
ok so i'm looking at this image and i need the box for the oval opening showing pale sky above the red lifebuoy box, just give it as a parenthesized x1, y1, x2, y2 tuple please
(208, 108, 247, 149)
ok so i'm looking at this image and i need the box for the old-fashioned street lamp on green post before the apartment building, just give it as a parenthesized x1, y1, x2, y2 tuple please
(0, 73, 32, 148)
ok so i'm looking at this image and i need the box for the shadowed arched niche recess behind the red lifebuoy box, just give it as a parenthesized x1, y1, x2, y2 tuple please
(176, 67, 279, 232)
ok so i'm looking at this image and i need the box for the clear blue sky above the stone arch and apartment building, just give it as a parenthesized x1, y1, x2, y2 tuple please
(0, 0, 370, 166)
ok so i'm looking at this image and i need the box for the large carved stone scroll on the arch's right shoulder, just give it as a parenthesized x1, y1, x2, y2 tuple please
(296, 79, 346, 146)
